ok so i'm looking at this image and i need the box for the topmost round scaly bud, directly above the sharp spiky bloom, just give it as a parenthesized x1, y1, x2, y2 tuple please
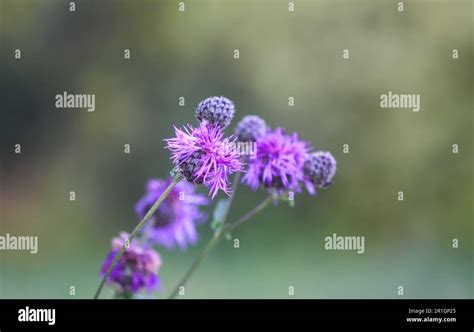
(196, 96, 235, 129)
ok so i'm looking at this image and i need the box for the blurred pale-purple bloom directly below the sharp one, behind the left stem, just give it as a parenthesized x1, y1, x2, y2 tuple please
(135, 179, 209, 250)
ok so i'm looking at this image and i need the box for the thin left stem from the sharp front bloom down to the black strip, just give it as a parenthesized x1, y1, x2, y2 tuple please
(94, 174, 183, 300)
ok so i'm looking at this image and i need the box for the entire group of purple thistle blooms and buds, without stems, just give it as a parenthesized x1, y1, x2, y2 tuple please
(102, 97, 336, 294)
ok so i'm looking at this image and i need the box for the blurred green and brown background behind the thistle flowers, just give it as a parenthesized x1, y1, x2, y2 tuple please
(0, 0, 474, 298)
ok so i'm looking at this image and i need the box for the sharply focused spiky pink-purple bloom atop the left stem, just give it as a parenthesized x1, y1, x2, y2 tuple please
(165, 122, 243, 198)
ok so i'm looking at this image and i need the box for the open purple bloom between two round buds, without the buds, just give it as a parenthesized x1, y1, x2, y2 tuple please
(243, 128, 309, 192)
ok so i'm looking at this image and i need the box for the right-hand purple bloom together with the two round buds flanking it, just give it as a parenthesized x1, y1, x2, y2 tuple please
(235, 116, 336, 195)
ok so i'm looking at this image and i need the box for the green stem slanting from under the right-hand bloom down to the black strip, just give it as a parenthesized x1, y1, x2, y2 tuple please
(168, 195, 272, 299)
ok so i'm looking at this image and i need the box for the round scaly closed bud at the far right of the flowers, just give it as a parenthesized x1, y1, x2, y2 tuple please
(303, 151, 337, 194)
